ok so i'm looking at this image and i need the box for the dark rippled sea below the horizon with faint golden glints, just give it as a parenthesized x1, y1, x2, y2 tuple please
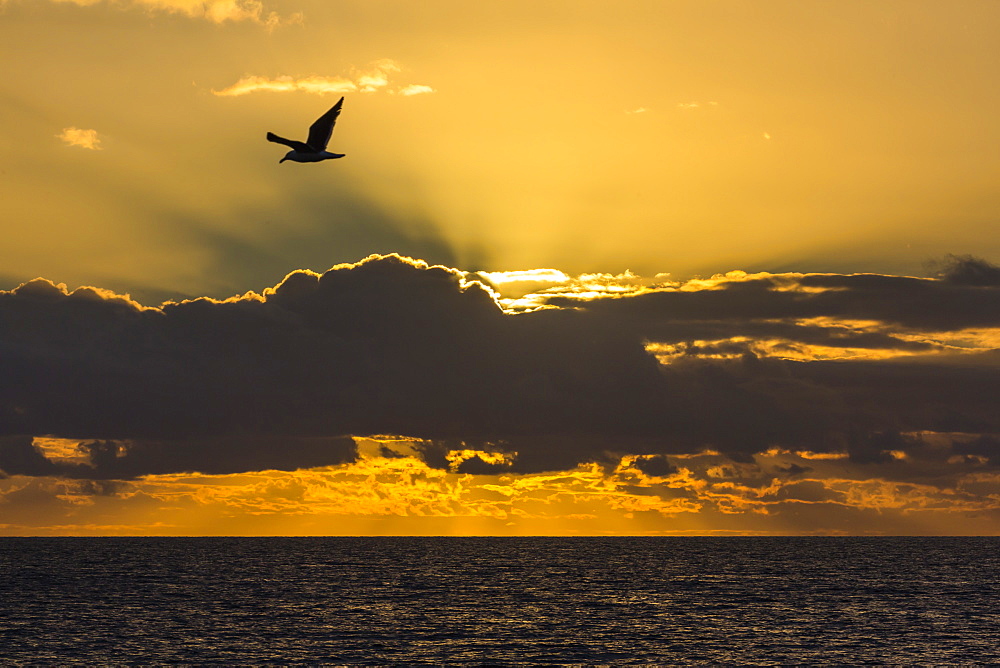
(0, 538, 1000, 665)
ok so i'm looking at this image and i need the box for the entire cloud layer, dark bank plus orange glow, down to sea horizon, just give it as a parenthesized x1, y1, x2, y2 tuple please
(0, 255, 1000, 533)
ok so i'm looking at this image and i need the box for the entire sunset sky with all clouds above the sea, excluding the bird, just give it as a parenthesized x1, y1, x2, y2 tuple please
(0, 0, 1000, 535)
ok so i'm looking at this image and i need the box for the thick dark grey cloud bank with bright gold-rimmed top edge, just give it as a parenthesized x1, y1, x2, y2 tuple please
(0, 256, 1000, 479)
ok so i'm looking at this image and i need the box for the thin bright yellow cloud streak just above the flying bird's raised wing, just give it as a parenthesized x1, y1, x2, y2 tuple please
(212, 58, 434, 97)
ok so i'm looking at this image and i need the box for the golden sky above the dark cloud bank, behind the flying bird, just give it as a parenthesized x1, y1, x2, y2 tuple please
(0, 0, 1000, 296)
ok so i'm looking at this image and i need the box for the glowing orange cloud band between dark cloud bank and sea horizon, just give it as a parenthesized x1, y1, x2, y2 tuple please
(0, 435, 1000, 535)
